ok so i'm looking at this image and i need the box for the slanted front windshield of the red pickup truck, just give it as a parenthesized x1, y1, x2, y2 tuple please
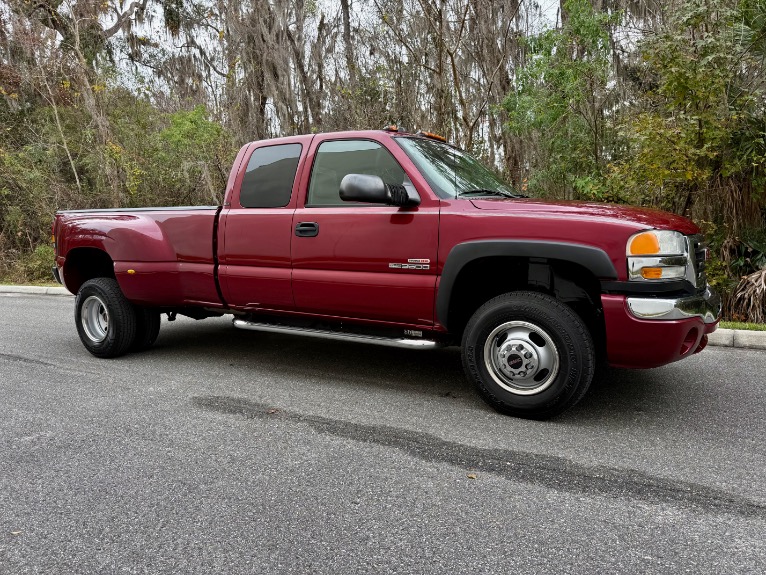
(396, 137, 524, 199)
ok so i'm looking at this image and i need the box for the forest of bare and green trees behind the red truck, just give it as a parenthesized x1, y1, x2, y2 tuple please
(0, 0, 766, 322)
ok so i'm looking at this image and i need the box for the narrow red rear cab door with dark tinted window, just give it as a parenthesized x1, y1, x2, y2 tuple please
(218, 136, 313, 310)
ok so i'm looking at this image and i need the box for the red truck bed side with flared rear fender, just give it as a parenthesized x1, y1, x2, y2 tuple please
(54, 206, 222, 307)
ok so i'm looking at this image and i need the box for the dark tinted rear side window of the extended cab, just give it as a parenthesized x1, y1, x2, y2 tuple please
(239, 144, 301, 208)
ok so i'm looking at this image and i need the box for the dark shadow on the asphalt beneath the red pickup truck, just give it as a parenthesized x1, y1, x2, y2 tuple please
(142, 319, 708, 424)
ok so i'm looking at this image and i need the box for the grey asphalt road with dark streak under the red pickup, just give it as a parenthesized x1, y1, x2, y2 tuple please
(0, 295, 766, 574)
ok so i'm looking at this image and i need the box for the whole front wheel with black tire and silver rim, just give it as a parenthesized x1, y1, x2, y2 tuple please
(462, 292, 596, 419)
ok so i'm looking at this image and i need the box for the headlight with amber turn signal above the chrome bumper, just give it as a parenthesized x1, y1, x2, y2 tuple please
(625, 230, 691, 281)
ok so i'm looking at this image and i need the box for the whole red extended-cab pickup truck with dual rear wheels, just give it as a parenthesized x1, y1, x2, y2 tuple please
(53, 127, 720, 419)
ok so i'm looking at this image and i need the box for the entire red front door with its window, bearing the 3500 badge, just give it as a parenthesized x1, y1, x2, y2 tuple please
(292, 134, 439, 327)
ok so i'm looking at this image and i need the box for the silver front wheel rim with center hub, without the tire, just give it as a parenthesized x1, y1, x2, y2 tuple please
(484, 321, 559, 395)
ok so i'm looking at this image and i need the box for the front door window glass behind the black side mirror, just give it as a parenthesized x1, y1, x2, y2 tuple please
(306, 140, 411, 207)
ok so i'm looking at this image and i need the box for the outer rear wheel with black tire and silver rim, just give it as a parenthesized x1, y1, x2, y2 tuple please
(74, 278, 136, 358)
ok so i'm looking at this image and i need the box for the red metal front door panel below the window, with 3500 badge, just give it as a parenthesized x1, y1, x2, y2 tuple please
(292, 206, 439, 327)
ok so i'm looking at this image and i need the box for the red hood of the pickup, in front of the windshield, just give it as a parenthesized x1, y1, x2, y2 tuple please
(470, 198, 699, 234)
